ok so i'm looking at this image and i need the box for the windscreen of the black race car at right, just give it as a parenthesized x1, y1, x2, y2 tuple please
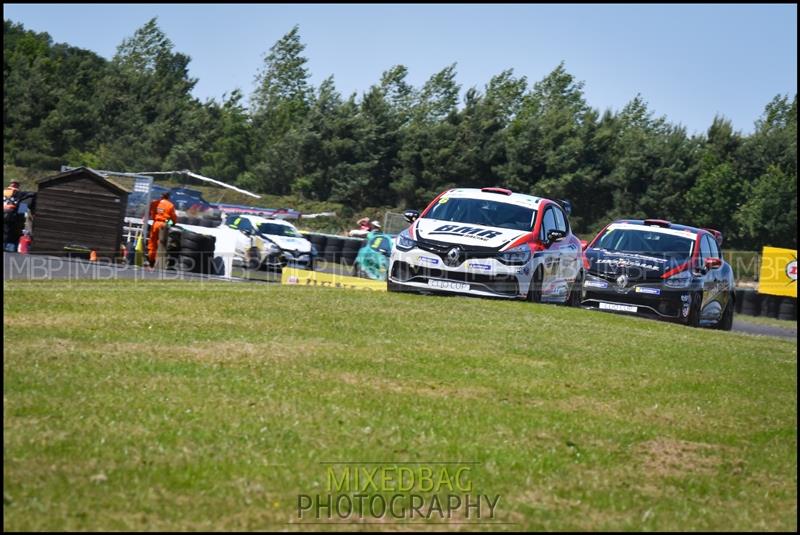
(592, 228, 694, 259)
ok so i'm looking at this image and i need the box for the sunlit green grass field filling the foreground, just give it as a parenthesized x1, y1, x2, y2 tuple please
(3, 282, 797, 531)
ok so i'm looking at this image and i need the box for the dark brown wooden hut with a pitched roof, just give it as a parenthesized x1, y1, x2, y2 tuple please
(31, 167, 128, 258)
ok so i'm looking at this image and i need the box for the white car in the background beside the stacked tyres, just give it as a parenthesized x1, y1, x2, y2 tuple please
(222, 214, 317, 271)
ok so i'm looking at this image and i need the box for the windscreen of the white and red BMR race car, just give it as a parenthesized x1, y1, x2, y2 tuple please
(425, 197, 536, 231)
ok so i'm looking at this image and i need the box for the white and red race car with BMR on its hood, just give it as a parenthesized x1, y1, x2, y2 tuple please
(387, 188, 584, 306)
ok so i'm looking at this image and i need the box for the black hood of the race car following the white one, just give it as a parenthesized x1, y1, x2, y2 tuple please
(584, 249, 687, 282)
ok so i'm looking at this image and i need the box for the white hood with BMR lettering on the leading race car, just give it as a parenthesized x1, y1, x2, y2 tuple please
(416, 219, 528, 250)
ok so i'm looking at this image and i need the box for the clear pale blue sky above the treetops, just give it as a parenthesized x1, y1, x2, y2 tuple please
(4, 4, 797, 134)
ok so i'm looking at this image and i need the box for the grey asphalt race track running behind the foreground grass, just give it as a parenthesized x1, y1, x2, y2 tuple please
(3, 252, 797, 339)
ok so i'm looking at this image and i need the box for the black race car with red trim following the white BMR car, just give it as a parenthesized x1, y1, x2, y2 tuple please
(581, 219, 734, 331)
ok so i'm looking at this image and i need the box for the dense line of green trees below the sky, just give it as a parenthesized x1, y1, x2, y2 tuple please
(3, 19, 797, 248)
